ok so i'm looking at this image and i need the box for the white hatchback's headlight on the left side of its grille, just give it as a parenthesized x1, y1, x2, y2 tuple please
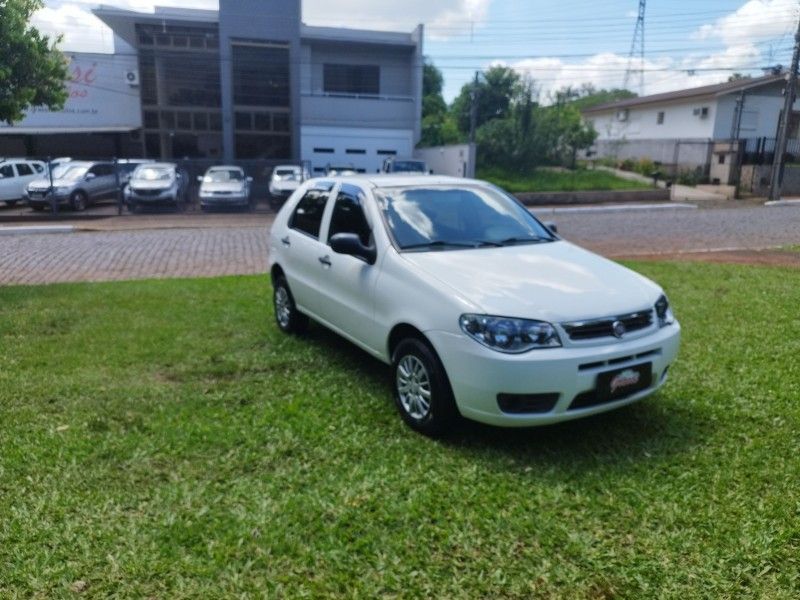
(459, 314, 561, 354)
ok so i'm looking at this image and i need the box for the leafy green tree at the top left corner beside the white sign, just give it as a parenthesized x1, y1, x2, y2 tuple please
(0, 0, 67, 125)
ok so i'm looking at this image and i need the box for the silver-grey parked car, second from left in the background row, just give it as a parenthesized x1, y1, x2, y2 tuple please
(27, 161, 119, 211)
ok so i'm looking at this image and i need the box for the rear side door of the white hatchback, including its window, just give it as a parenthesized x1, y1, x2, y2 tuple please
(277, 182, 333, 317)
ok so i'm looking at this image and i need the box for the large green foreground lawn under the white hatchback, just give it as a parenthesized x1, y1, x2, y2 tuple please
(0, 263, 800, 599)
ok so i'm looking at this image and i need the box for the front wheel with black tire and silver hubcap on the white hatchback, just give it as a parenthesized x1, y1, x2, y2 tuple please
(392, 337, 460, 437)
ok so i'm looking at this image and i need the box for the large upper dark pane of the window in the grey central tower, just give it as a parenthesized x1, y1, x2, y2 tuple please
(233, 44, 289, 106)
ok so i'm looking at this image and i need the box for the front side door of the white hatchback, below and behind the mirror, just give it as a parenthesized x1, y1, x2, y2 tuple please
(320, 183, 382, 351)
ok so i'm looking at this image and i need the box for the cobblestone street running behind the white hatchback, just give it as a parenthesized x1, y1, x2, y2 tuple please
(0, 207, 800, 284)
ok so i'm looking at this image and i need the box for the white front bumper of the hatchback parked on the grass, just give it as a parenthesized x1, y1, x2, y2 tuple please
(426, 322, 680, 427)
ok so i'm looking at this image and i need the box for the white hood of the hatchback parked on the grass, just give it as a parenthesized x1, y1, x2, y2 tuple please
(402, 241, 660, 322)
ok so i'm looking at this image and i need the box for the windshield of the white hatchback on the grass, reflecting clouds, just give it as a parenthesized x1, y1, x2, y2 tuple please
(375, 185, 557, 250)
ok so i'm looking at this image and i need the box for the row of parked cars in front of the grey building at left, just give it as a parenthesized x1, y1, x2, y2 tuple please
(0, 158, 309, 212)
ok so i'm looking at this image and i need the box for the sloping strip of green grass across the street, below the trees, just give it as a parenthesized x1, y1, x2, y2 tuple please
(477, 168, 648, 193)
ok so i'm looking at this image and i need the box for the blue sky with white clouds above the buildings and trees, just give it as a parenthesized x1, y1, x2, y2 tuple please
(35, 0, 800, 102)
